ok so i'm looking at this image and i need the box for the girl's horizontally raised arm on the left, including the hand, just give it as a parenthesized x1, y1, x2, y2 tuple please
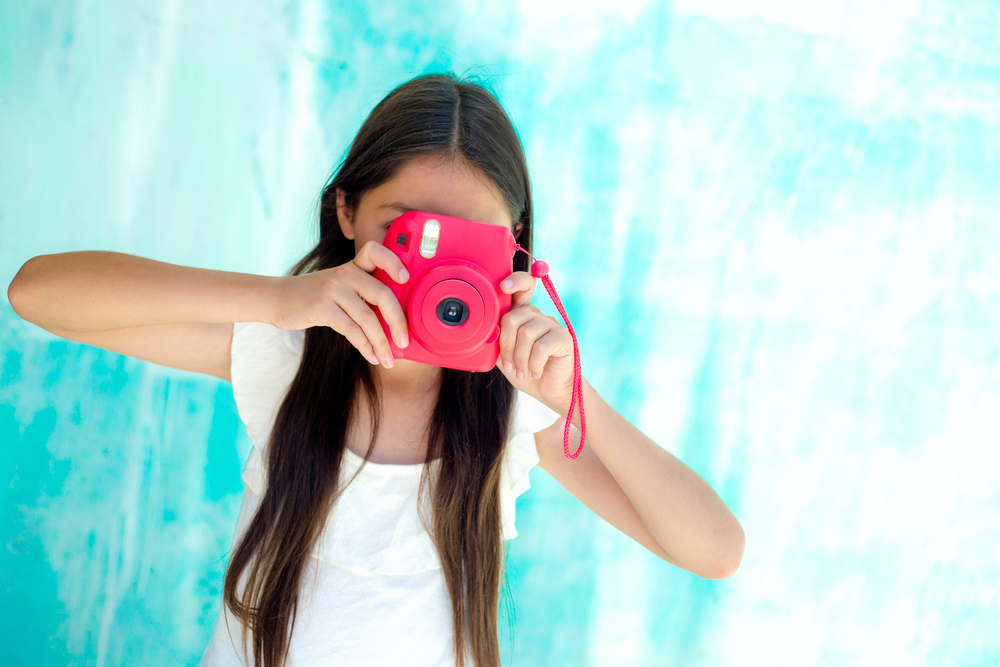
(7, 244, 406, 380)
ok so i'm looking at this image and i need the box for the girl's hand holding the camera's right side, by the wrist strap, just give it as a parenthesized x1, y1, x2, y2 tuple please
(497, 271, 573, 414)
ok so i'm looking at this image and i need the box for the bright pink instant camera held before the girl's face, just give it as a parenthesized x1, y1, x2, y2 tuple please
(372, 211, 515, 372)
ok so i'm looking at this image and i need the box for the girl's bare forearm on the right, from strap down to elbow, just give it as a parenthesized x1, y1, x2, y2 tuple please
(549, 378, 745, 579)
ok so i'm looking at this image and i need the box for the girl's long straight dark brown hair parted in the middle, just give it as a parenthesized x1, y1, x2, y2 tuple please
(223, 74, 532, 667)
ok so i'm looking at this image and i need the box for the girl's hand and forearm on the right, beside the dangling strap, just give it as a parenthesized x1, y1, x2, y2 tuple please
(497, 271, 745, 579)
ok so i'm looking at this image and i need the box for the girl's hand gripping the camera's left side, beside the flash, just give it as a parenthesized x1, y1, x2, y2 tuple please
(269, 241, 410, 368)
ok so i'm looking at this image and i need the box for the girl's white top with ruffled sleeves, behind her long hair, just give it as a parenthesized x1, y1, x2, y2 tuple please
(199, 322, 559, 667)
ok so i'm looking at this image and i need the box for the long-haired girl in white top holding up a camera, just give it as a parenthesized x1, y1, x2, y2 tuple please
(8, 76, 744, 667)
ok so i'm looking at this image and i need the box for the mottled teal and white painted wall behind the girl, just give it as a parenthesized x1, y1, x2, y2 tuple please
(0, 0, 1000, 667)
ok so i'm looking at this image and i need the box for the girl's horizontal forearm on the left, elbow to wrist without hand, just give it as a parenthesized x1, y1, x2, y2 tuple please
(7, 251, 282, 332)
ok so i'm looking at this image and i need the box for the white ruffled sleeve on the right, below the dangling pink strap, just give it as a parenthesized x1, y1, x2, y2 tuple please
(500, 390, 559, 540)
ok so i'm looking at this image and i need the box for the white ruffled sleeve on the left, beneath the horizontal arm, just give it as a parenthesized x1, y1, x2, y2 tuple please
(230, 322, 305, 495)
